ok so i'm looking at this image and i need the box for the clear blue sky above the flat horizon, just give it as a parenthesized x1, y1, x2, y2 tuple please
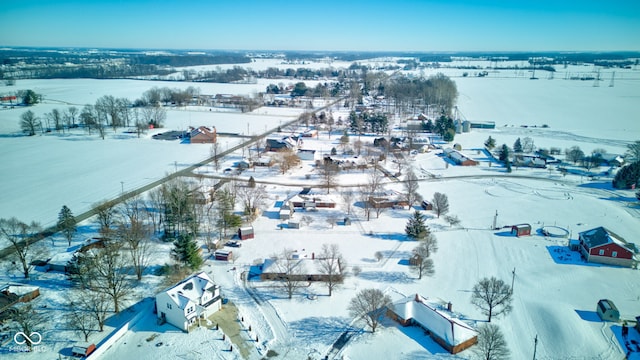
(0, 0, 640, 51)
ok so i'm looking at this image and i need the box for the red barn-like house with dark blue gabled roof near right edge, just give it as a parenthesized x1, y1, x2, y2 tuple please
(578, 226, 637, 267)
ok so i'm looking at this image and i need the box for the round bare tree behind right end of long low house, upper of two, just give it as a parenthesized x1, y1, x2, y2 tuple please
(471, 277, 513, 322)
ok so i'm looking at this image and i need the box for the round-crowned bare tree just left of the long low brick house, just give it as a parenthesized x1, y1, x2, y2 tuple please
(347, 289, 391, 333)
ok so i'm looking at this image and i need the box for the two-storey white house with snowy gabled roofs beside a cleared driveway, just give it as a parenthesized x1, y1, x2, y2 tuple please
(156, 272, 222, 331)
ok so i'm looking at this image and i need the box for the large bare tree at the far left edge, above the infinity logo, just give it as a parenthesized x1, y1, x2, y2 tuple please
(0, 217, 44, 279)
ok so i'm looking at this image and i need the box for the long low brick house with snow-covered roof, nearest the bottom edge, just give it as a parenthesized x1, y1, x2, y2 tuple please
(387, 294, 478, 354)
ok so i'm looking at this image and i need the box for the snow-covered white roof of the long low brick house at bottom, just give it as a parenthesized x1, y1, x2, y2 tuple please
(392, 294, 478, 346)
